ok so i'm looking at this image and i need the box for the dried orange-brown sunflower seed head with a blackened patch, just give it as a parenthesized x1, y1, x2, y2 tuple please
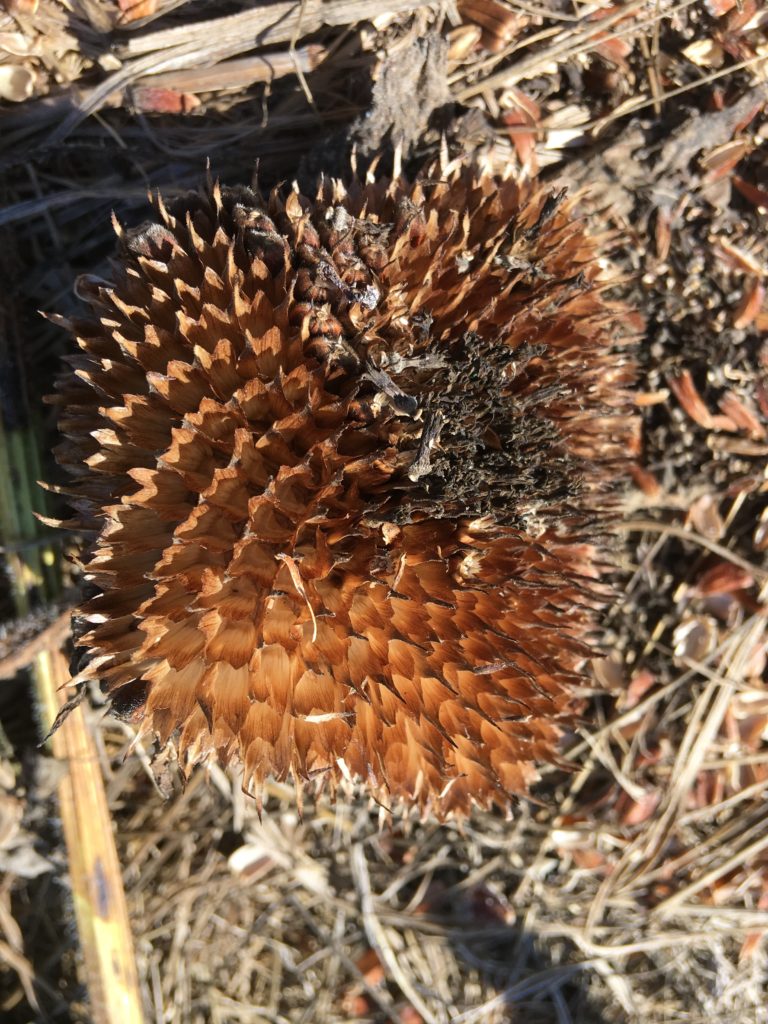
(57, 163, 637, 814)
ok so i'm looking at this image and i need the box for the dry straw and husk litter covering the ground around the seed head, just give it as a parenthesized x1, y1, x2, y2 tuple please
(0, 0, 768, 1024)
